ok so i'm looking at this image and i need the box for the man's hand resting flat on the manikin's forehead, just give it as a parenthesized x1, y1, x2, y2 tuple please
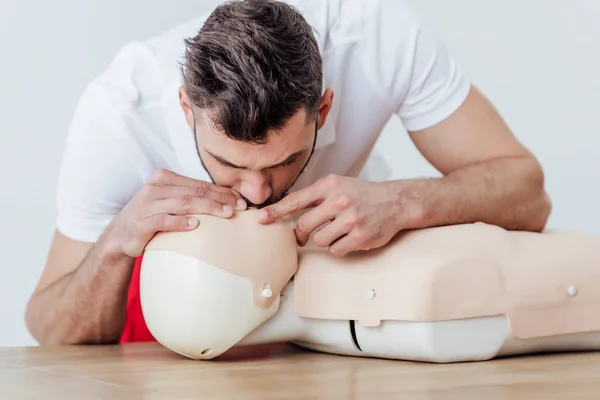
(103, 170, 246, 257)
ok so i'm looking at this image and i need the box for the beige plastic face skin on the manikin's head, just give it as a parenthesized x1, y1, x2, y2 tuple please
(146, 209, 298, 309)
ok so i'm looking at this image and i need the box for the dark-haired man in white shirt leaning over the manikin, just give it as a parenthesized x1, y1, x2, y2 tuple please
(26, 0, 550, 344)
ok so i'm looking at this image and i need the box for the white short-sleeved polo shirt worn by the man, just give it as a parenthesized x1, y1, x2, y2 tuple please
(57, 0, 470, 242)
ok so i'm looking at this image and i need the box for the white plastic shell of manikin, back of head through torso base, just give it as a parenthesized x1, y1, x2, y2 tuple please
(140, 251, 600, 363)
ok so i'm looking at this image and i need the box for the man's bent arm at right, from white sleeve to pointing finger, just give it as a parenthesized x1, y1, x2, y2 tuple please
(259, 0, 551, 256)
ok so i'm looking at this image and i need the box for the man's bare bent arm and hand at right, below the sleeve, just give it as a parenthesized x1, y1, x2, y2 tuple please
(260, 89, 551, 256)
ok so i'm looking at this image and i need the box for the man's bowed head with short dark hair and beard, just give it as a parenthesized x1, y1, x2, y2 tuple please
(179, 0, 333, 208)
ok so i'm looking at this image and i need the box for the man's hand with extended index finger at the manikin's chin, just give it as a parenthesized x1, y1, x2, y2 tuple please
(260, 175, 419, 256)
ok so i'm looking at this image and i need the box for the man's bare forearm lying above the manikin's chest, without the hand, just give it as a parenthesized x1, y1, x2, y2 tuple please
(396, 157, 551, 232)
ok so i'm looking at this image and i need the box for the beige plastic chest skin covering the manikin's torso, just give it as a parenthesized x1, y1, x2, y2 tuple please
(294, 223, 600, 339)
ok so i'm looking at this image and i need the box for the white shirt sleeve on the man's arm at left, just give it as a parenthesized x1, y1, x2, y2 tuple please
(56, 82, 143, 242)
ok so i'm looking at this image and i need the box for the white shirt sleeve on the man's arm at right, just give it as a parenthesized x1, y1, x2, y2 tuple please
(363, 0, 471, 131)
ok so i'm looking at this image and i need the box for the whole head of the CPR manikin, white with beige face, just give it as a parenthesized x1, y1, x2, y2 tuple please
(140, 209, 298, 359)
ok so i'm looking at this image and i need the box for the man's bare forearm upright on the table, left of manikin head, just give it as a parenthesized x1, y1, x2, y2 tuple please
(26, 239, 134, 344)
